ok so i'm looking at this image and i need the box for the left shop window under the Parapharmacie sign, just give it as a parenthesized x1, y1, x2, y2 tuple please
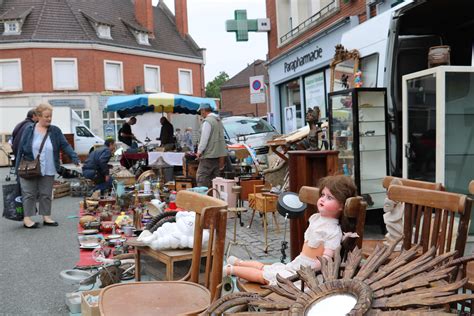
(280, 79, 305, 133)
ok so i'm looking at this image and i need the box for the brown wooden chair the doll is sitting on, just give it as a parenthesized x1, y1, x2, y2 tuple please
(237, 186, 367, 299)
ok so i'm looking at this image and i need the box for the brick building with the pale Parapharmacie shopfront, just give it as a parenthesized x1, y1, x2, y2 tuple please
(266, 0, 391, 132)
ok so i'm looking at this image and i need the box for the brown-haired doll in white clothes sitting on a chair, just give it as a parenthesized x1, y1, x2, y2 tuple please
(223, 175, 358, 285)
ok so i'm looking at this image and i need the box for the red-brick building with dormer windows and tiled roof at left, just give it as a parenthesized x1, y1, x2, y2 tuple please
(0, 0, 204, 136)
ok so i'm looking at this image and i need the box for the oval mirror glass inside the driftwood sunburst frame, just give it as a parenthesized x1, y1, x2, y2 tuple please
(305, 293, 357, 316)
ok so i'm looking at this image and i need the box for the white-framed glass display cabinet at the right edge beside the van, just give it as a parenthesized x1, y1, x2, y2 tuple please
(402, 66, 474, 194)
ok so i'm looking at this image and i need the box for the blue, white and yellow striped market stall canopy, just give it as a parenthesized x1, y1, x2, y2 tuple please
(105, 92, 216, 118)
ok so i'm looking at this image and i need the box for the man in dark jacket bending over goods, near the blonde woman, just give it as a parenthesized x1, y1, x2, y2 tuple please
(82, 139, 115, 193)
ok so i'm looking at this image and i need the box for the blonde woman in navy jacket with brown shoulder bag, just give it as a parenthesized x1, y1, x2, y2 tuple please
(16, 103, 80, 228)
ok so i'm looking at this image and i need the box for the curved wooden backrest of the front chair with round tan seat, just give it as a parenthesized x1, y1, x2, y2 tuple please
(176, 190, 227, 301)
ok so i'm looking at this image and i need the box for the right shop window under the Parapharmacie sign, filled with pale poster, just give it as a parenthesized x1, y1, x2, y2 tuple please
(304, 71, 327, 117)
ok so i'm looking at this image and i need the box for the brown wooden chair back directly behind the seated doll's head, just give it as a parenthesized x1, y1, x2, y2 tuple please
(299, 186, 367, 248)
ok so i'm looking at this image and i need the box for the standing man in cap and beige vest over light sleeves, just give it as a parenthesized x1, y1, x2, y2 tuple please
(196, 103, 227, 188)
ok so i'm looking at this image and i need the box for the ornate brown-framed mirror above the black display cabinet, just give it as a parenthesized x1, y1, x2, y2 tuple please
(330, 44, 359, 92)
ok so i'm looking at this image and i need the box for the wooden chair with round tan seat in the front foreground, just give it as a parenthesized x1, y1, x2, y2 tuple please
(99, 191, 227, 316)
